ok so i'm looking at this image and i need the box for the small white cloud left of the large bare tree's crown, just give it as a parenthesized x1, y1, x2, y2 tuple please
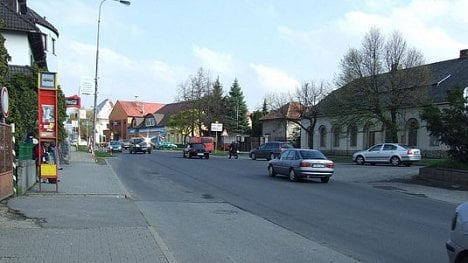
(250, 64, 300, 92)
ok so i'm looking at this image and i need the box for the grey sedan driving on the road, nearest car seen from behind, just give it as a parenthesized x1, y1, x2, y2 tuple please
(268, 148, 335, 183)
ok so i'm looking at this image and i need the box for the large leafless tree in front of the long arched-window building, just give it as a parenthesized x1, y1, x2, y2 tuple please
(323, 28, 429, 142)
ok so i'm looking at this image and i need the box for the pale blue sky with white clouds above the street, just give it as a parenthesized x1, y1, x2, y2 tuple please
(28, 0, 468, 111)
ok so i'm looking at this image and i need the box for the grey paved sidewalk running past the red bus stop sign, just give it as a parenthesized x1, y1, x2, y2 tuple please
(0, 152, 168, 263)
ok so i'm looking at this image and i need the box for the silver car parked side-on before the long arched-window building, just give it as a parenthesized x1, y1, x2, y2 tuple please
(353, 143, 421, 166)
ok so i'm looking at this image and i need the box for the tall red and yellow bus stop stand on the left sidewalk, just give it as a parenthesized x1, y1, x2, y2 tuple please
(37, 72, 59, 192)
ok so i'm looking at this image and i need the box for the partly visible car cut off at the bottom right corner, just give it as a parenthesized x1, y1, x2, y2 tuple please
(445, 202, 468, 263)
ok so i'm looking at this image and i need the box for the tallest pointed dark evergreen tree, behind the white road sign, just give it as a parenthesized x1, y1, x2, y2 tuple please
(225, 78, 250, 134)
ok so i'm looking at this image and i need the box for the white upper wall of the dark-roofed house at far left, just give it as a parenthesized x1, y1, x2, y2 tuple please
(2, 32, 32, 66)
